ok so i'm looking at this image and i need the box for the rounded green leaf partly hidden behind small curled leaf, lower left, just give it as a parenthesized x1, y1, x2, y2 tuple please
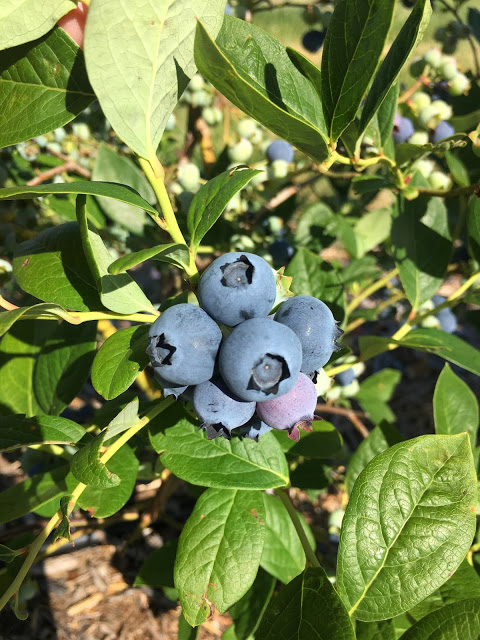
(77, 444, 138, 518)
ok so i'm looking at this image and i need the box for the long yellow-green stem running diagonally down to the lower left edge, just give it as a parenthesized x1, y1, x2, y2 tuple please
(0, 396, 174, 611)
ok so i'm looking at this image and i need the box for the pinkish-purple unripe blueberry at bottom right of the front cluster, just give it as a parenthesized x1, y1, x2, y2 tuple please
(257, 373, 317, 440)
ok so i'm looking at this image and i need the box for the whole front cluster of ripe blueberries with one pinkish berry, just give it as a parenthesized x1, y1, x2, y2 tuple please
(147, 252, 342, 440)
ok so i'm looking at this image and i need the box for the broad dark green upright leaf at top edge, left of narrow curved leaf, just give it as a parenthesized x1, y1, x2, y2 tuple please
(322, 0, 395, 142)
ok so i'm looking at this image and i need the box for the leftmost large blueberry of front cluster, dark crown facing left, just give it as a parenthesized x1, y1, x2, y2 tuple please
(147, 303, 222, 387)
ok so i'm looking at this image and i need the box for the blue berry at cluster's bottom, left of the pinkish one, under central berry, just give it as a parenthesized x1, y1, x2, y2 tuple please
(193, 379, 255, 440)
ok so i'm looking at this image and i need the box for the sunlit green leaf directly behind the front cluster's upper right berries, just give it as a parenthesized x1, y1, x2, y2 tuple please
(285, 248, 345, 320)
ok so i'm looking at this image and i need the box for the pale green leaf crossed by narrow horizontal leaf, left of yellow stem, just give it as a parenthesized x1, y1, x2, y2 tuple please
(92, 142, 157, 235)
